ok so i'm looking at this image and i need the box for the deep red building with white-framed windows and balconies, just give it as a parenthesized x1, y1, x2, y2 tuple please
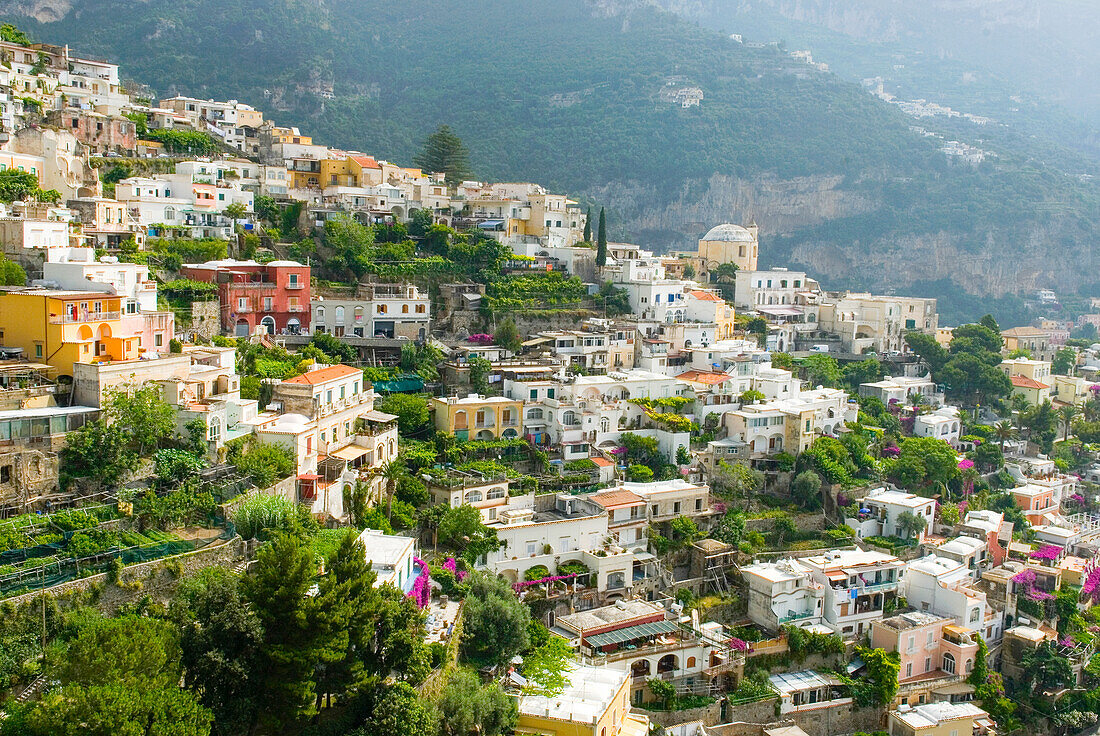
(180, 259, 309, 337)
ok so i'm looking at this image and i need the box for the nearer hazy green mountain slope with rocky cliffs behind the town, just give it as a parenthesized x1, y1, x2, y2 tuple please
(0, 0, 1100, 319)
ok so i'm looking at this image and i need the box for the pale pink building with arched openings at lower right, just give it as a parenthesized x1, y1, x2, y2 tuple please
(871, 611, 978, 683)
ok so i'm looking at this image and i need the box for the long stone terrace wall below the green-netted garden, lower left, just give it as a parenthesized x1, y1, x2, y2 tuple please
(4, 537, 255, 614)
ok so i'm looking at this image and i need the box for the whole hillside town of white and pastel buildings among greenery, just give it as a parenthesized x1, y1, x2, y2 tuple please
(0, 26, 1100, 736)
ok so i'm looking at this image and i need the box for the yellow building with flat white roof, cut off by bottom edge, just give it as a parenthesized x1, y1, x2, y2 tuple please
(516, 666, 649, 736)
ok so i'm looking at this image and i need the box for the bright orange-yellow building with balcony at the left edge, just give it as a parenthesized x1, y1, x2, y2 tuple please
(0, 289, 141, 375)
